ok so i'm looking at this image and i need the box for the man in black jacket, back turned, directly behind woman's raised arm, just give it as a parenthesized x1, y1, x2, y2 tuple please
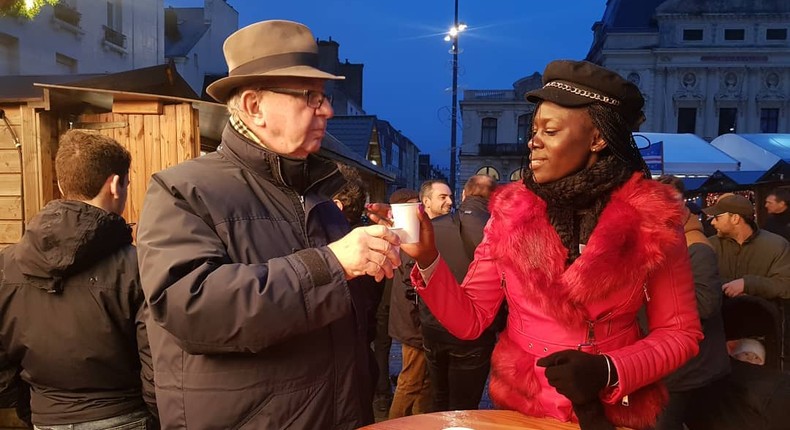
(420, 175, 496, 411)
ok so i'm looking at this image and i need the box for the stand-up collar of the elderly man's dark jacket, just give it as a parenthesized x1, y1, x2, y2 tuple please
(217, 123, 344, 198)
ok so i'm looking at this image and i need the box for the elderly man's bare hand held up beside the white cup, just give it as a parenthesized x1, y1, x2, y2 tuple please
(329, 225, 400, 282)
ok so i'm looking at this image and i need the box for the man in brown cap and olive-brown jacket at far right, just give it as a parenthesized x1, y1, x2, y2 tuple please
(702, 193, 790, 299)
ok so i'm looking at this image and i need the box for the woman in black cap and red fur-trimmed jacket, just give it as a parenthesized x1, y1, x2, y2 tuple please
(402, 61, 702, 429)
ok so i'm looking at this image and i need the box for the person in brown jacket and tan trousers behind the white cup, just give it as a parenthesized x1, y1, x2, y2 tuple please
(389, 188, 431, 419)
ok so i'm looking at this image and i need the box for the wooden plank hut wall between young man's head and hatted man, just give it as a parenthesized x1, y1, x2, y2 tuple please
(79, 103, 200, 237)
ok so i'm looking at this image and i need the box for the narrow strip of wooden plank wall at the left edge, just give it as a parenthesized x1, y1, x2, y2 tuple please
(0, 104, 22, 248)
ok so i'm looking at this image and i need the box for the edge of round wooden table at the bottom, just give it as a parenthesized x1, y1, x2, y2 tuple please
(360, 410, 579, 430)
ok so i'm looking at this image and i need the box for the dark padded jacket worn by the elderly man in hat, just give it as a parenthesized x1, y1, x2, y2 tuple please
(138, 125, 372, 429)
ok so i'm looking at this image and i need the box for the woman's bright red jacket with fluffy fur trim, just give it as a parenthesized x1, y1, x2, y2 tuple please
(412, 174, 702, 429)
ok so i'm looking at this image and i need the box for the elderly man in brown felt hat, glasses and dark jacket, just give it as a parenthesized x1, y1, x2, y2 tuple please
(138, 21, 400, 429)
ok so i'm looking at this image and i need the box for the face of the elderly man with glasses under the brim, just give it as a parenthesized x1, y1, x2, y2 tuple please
(245, 78, 334, 158)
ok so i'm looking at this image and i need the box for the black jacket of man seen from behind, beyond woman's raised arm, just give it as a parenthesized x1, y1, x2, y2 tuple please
(420, 196, 500, 346)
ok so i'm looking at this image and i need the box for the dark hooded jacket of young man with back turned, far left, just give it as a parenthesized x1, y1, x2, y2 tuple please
(0, 200, 156, 425)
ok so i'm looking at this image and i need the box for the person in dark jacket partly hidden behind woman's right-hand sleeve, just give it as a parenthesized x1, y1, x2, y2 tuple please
(656, 175, 730, 430)
